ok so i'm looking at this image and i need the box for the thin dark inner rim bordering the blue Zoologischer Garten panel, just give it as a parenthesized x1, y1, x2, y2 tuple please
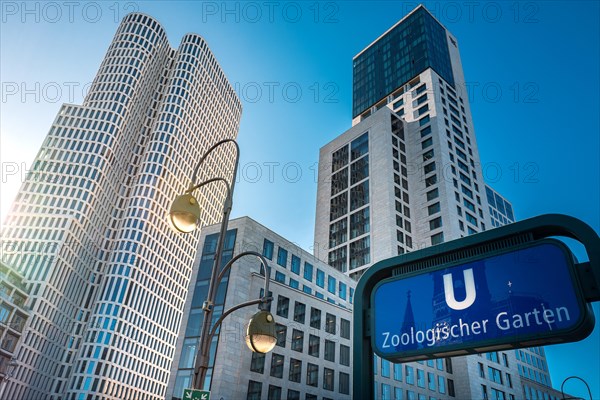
(369, 239, 595, 363)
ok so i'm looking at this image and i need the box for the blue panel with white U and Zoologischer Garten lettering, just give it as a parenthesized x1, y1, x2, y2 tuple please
(371, 240, 593, 361)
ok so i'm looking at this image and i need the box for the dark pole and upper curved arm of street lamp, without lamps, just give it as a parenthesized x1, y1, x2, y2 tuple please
(192, 139, 240, 389)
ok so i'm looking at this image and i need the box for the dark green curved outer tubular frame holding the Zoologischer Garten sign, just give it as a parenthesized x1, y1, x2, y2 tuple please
(352, 214, 600, 399)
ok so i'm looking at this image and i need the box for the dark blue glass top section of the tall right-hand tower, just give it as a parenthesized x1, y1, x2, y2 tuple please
(352, 7, 454, 118)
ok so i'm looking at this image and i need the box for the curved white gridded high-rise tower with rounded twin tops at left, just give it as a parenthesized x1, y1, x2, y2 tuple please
(2, 13, 241, 400)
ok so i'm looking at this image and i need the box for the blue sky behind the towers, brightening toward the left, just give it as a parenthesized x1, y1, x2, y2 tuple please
(0, 1, 600, 398)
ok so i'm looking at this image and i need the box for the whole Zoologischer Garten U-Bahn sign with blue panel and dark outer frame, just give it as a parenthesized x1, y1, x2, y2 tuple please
(353, 214, 600, 399)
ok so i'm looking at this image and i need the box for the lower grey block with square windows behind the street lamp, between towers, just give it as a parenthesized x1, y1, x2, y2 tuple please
(166, 217, 355, 400)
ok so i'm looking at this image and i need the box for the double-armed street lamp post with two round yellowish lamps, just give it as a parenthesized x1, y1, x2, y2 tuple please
(168, 139, 277, 389)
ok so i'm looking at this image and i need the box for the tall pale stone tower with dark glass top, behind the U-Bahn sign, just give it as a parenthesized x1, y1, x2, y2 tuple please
(314, 5, 564, 400)
